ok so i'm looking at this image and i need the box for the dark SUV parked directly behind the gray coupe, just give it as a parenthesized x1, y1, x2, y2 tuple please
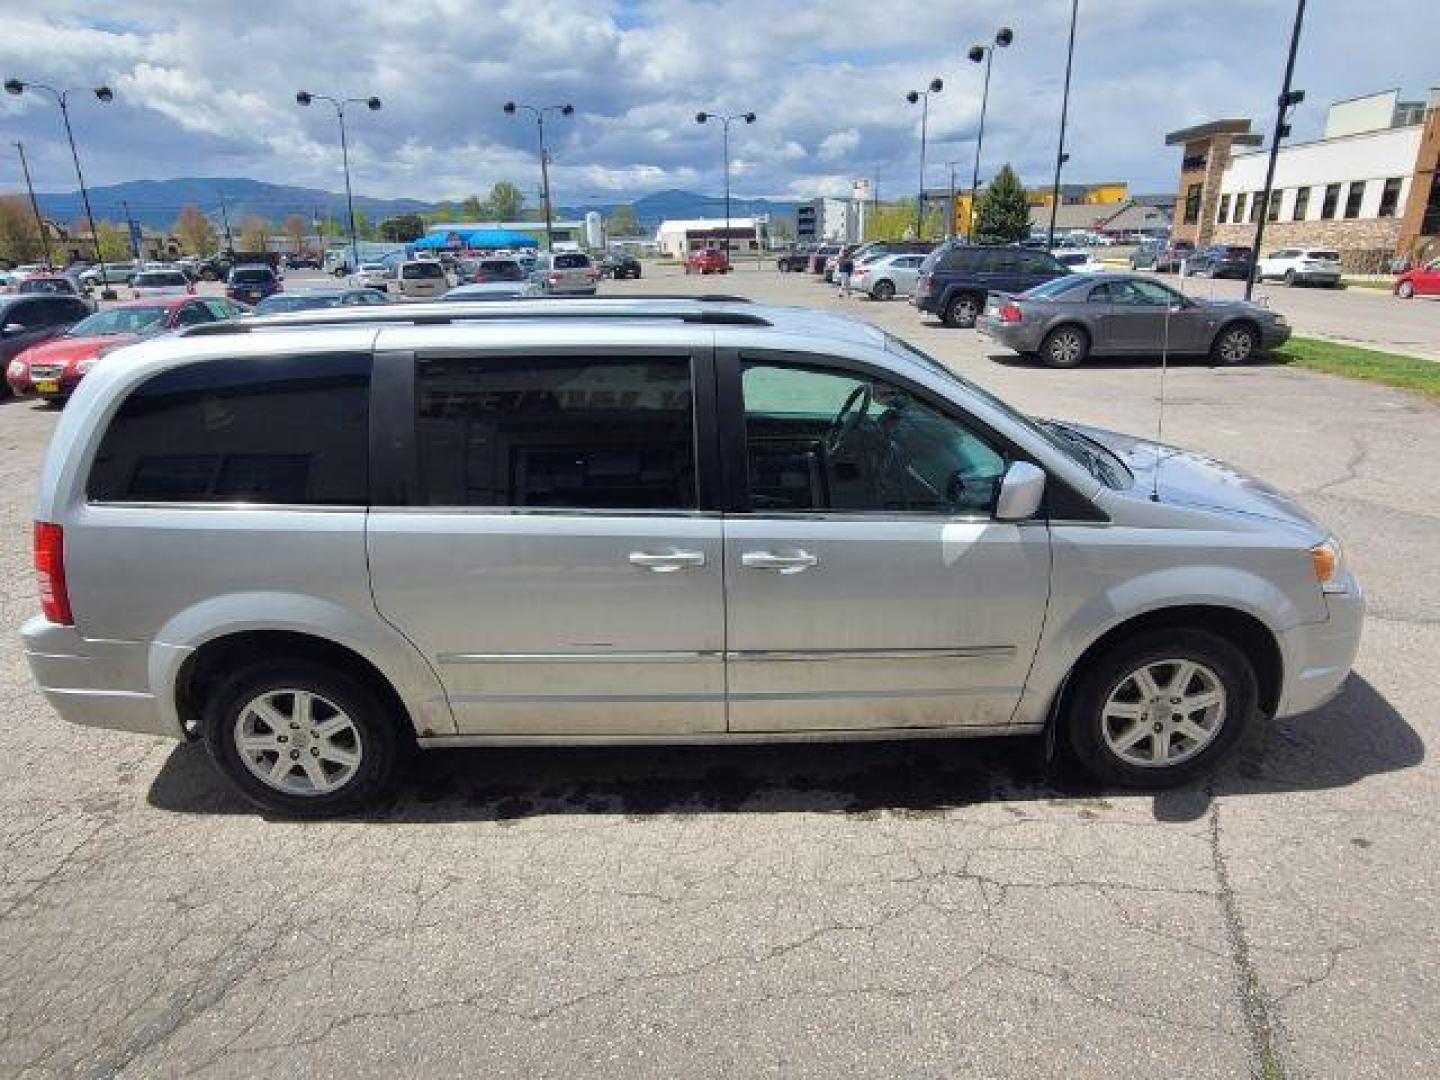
(910, 243, 1070, 327)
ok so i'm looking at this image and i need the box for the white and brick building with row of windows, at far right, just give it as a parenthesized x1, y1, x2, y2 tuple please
(1165, 91, 1440, 271)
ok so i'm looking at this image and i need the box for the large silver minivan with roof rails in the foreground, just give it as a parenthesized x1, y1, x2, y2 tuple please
(22, 298, 1364, 815)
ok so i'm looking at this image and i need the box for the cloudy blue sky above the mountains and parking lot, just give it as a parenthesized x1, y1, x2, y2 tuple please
(0, 0, 1440, 203)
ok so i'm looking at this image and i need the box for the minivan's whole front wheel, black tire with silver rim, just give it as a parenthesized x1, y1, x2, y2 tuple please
(1061, 629, 1259, 788)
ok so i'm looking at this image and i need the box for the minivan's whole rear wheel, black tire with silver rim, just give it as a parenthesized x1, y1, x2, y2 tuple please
(200, 661, 403, 818)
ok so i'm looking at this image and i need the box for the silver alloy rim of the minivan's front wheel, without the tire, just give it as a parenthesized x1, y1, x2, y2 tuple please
(1100, 657, 1225, 769)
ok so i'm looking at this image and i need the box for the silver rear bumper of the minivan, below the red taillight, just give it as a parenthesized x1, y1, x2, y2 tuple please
(20, 615, 184, 739)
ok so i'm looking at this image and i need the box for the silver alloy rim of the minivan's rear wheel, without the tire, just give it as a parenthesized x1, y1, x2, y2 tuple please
(235, 688, 364, 795)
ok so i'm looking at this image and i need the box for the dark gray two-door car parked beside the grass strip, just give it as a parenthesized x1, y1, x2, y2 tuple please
(975, 274, 1290, 367)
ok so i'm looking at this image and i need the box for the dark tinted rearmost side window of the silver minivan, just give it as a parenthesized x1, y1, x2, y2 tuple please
(88, 353, 370, 505)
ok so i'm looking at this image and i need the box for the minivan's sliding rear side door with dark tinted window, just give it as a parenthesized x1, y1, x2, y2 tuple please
(367, 350, 724, 736)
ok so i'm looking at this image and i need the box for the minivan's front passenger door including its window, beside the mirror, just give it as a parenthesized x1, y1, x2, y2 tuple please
(720, 353, 1050, 732)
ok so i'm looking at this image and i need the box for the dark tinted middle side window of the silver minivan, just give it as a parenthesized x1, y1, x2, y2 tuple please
(415, 356, 696, 510)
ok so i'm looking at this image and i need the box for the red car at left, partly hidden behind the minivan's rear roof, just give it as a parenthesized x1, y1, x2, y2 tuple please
(4, 297, 246, 400)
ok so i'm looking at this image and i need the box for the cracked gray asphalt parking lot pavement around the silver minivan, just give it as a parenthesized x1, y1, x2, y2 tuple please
(0, 264, 1440, 1077)
